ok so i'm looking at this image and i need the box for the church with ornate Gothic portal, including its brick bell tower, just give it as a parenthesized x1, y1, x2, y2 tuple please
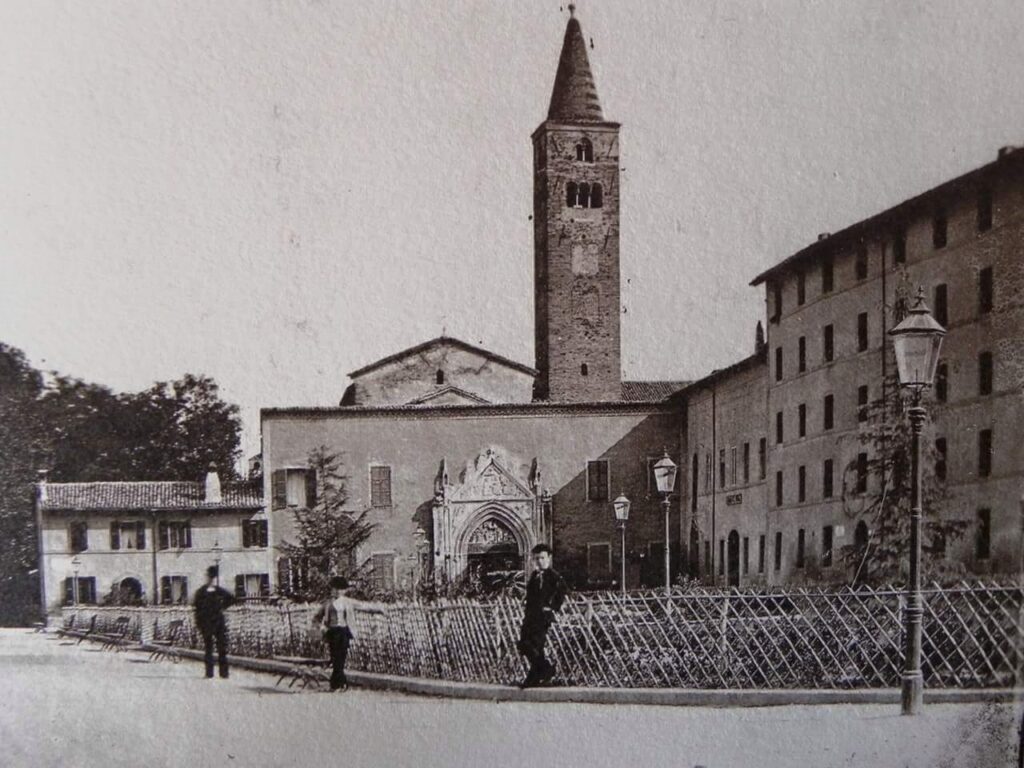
(261, 6, 684, 588)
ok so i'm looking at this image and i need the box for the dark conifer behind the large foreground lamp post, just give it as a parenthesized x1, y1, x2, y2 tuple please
(843, 376, 969, 584)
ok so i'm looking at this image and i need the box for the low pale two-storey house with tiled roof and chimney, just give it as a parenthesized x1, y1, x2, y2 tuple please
(36, 472, 270, 615)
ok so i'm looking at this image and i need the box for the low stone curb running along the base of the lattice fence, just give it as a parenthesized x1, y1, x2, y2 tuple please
(141, 646, 1024, 707)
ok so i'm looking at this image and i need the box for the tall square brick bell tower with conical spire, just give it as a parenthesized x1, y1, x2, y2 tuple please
(532, 5, 622, 402)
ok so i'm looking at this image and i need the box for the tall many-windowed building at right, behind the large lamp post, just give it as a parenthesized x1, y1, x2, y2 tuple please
(752, 147, 1024, 582)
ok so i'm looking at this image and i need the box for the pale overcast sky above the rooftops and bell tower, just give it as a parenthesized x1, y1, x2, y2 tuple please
(0, 0, 1024, 462)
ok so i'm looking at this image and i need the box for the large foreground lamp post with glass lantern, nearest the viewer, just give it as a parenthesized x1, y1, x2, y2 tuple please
(889, 289, 946, 715)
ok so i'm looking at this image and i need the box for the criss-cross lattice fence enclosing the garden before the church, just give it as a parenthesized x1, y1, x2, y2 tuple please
(65, 583, 1024, 689)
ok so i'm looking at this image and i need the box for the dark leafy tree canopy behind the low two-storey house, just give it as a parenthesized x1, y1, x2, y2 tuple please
(0, 342, 242, 624)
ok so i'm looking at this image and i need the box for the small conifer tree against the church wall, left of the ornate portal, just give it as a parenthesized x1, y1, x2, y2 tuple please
(282, 445, 374, 600)
